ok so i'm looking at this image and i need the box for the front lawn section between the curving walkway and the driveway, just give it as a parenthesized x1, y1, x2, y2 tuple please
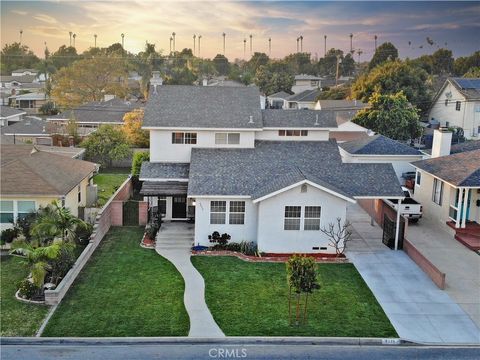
(192, 256, 397, 337)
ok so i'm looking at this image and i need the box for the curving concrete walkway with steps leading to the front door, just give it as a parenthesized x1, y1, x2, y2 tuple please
(155, 222, 225, 338)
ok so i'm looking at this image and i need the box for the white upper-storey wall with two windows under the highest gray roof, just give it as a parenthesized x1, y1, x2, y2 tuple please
(150, 129, 255, 162)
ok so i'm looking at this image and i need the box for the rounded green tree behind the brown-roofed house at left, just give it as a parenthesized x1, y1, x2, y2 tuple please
(80, 125, 131, 167)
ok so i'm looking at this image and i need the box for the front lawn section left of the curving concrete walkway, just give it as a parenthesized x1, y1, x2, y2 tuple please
(43, 227, 189, 336)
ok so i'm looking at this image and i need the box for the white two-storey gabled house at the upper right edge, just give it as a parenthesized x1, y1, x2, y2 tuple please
(428, 78, 480, 139)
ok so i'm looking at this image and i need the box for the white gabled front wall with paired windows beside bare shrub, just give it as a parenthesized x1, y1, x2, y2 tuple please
(257, 185, 347, 254)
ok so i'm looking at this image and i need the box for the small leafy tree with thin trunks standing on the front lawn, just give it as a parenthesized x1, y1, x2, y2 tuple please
(287, 255, 320, 325)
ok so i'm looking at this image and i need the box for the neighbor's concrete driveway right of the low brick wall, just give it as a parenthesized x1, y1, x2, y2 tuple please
(406, 219, 480, 327)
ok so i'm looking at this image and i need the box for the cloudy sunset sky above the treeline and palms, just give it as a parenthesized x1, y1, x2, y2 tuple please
(1, 0, 480, 60)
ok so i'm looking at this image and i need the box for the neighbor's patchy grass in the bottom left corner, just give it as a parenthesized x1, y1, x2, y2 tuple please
(0, 256, 49, 336)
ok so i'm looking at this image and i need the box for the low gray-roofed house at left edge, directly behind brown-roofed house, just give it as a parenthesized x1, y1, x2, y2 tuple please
(1, 116, 52, 144)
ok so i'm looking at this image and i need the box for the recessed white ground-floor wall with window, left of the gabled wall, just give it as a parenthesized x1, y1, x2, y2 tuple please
(195, 197, 258, 246)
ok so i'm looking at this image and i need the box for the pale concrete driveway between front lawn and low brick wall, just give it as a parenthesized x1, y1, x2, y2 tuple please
(347, 205, 480, 344)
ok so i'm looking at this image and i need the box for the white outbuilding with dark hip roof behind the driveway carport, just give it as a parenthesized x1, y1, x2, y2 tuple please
(338, 135, 424, 182)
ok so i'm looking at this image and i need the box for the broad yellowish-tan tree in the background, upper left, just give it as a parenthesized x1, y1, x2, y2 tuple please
(52, 57, 128, 108)
